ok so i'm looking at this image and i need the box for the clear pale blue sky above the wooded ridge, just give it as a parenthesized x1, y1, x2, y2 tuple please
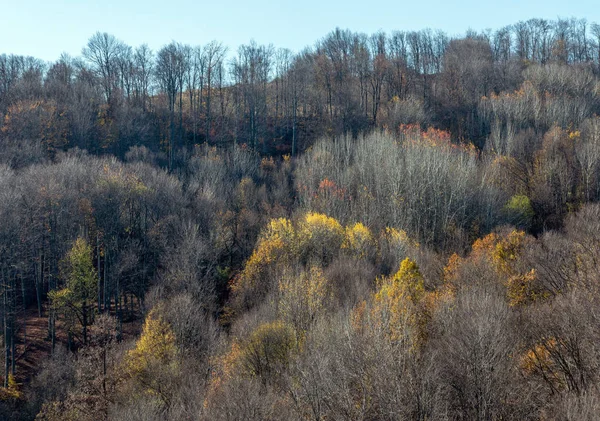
(0, 0, 600, 61)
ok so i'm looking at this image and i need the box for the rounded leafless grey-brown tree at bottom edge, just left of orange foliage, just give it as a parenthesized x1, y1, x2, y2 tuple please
(433, 286, 532, 421)
